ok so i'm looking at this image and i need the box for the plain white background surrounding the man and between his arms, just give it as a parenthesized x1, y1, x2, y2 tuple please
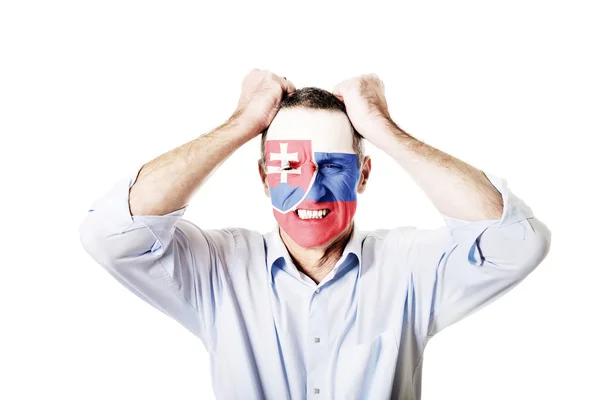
(0, 0, 600, 400)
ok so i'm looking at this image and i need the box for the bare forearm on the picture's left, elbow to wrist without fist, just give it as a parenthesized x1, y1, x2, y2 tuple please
(129, 114, 260, 215)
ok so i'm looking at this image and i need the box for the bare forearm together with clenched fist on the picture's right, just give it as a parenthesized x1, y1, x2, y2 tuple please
(333, 74, 504, 221)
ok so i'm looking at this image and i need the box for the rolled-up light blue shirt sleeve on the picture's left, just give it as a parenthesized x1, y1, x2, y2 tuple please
(79, 166, 211, 340)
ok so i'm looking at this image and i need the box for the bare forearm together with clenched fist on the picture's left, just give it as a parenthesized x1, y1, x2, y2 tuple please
(129, 69, 295, 215)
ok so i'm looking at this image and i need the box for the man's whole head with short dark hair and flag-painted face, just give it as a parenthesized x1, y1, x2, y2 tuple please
(259, 87, 371, 248)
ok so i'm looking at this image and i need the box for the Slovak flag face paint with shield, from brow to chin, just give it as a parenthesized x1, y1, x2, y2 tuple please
(265, 139, 360, 247)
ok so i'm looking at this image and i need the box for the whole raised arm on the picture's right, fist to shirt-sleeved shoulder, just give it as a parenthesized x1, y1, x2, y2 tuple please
(334, 74, 551, 336)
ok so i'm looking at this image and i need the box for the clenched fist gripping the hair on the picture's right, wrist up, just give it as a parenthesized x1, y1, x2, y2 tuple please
(332, 74, 392, 145)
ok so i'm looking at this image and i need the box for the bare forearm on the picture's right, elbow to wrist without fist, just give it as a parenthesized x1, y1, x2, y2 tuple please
(378, 121, 503, 221)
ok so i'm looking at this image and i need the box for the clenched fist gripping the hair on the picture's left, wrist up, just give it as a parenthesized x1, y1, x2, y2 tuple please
(234, 68, 296, 134)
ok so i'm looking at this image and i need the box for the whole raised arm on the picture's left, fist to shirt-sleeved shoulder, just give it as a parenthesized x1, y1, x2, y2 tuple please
(79, 70, 295, 345)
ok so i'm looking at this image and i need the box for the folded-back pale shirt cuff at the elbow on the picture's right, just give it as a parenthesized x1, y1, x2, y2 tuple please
(441, 172, 533, 265)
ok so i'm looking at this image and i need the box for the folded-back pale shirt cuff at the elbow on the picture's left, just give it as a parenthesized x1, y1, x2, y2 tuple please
(88, 164, 187, 254)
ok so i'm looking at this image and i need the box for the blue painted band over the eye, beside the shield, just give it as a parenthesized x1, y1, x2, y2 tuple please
(306, 152, 360, 202)
